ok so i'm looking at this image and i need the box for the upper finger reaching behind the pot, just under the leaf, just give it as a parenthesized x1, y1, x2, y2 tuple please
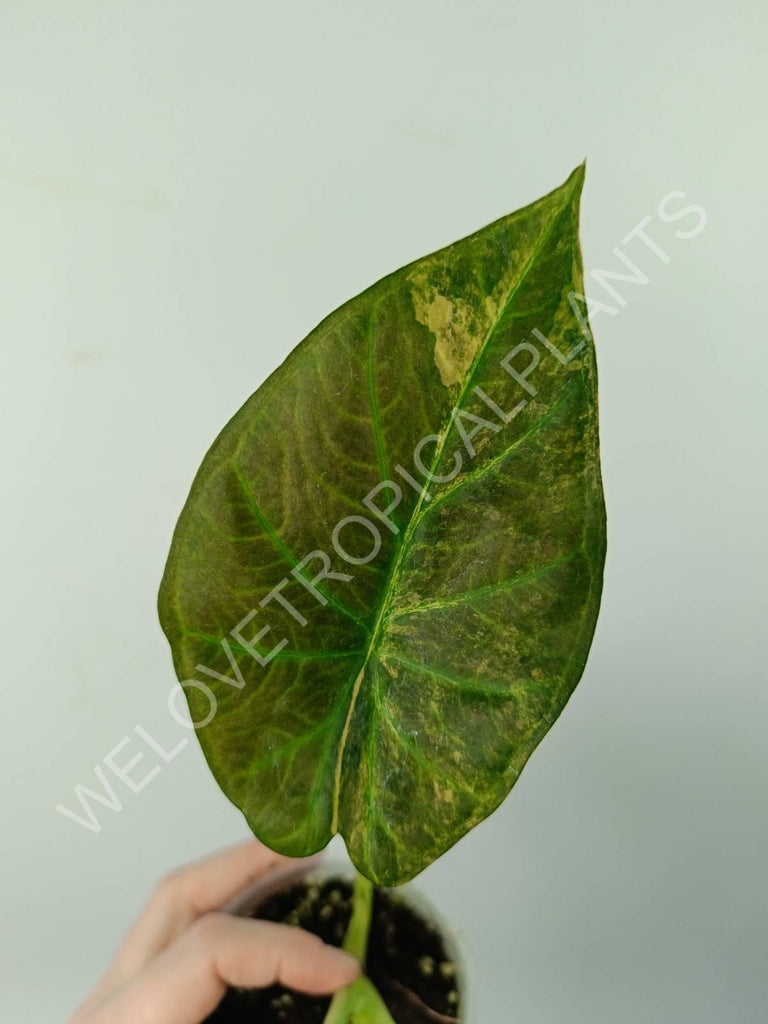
(109, 840, 300, 983)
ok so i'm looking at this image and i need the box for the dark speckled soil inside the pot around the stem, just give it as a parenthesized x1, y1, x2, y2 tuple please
(207, 879, 460, 1024)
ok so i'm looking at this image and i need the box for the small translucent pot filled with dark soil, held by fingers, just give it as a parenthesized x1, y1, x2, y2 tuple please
(204, 863, 469, 1024)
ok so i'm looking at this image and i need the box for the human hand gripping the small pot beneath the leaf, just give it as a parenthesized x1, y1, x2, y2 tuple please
(70, 841, 360, 1024)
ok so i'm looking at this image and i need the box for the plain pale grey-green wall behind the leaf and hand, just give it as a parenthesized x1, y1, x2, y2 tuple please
(0, 0, 768, 1024)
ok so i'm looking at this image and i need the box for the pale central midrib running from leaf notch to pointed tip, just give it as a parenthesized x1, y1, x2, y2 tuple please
(331, 189, 571, 836)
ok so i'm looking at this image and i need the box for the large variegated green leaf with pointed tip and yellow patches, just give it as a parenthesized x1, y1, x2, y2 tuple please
(160, 168, 605, 884)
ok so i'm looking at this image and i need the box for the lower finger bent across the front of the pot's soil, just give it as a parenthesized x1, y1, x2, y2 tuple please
(85, 913, 360, 1024)
